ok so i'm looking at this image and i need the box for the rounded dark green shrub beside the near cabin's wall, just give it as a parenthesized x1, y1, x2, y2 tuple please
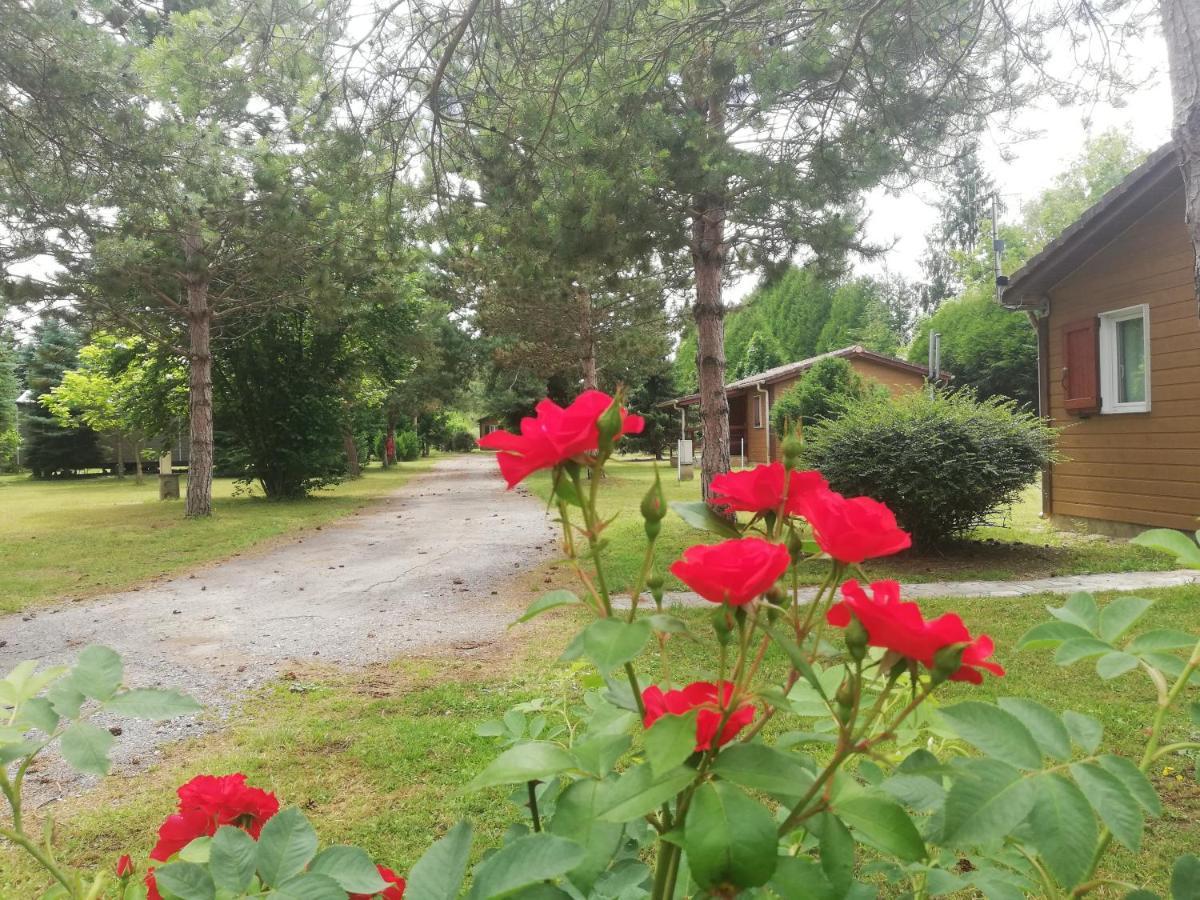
(803, 390, 1057, 546)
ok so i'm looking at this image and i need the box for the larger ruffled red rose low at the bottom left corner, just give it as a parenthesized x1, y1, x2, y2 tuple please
(150, 773, 280, 862)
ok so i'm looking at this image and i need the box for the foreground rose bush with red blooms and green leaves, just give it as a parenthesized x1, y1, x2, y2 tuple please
(0, 392, 1200, 900)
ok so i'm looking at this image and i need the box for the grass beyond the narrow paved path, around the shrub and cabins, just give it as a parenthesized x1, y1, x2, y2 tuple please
(528, 460, 1175, 590)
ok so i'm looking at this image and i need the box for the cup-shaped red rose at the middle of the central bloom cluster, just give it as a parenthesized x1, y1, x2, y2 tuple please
(671, 538, 792, 606)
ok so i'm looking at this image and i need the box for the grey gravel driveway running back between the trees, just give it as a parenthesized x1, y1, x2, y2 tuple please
(0, 452, 556, 794)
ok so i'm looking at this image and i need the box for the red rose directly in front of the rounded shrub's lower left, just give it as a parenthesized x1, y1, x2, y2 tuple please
(799, 490, 912, 564)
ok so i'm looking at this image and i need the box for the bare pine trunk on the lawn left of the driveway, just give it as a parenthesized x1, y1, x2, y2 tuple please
(184, 232, 212, 518)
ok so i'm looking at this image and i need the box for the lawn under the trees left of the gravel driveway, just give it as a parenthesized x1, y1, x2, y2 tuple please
(0, 460, 432, 613)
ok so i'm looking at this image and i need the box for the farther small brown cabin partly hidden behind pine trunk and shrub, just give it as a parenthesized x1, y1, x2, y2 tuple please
(662, 344, 928, 464)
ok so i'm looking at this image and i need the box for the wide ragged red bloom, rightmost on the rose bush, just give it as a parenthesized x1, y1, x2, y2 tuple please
(826, 581, 1004, 684)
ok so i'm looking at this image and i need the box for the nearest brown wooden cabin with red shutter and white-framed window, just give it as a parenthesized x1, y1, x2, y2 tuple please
(1001, 145, 1200, 535)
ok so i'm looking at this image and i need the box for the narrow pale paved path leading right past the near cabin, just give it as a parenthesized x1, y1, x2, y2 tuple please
(618, 569, 1200, 608)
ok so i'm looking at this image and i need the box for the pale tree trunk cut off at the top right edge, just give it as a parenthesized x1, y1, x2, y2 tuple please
(1159, 0, 1200, 301)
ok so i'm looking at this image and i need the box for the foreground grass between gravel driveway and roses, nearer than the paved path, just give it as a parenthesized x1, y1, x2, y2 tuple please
(0, 587, 1200, 898)
